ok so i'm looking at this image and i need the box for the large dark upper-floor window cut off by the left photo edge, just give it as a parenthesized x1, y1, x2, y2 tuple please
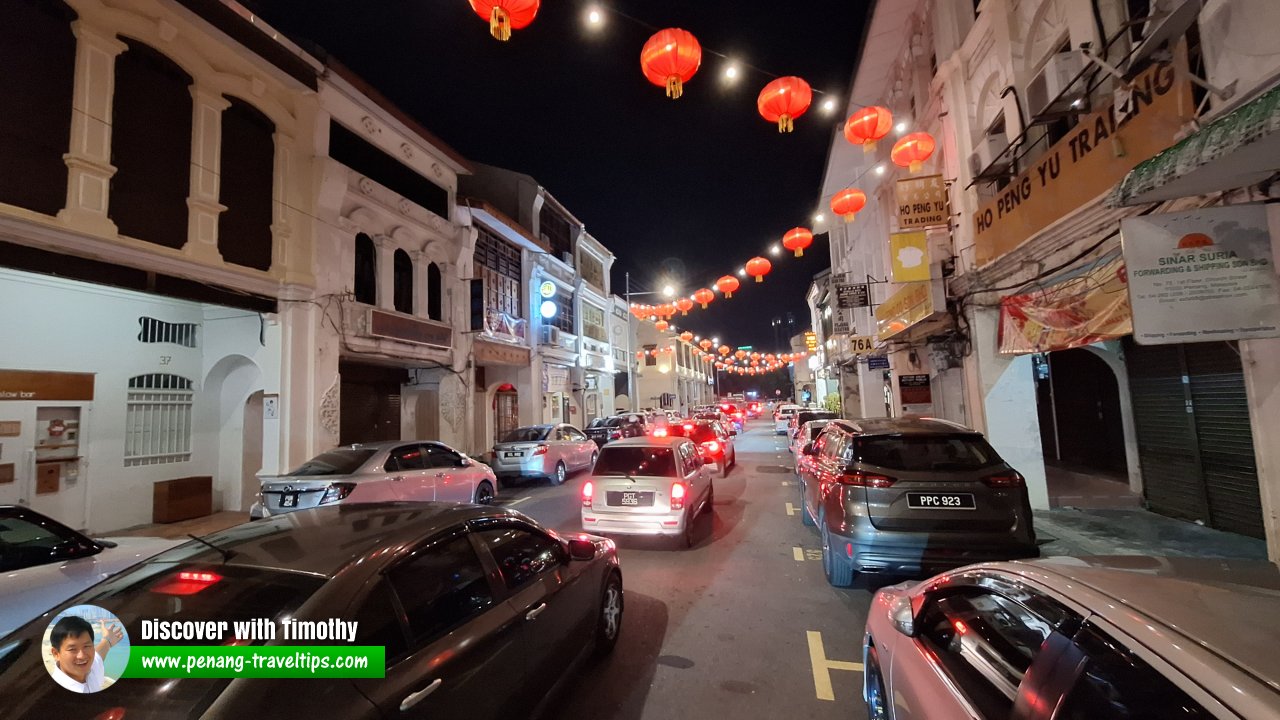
(0, 0, 76, 215)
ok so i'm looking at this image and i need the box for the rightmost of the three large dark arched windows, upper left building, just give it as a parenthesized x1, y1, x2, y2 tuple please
(218, 97, 275, 270)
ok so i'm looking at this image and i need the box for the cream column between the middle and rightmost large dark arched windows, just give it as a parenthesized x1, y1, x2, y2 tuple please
(182, 83, 236, 263)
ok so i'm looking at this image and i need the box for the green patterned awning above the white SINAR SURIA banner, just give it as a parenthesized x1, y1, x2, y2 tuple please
(1110, 86, 1280, 208)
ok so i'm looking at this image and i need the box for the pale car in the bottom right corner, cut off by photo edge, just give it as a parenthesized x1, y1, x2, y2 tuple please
(863, 556, 1280, 720)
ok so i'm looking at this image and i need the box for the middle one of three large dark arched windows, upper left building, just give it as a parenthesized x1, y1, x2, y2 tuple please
(109, 37, 191, 249)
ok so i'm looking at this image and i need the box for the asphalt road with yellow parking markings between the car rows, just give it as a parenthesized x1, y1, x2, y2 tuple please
(488, 421, 890, 720)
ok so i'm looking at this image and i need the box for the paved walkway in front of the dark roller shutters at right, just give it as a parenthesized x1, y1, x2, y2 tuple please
(1036, 507, 1267, 560)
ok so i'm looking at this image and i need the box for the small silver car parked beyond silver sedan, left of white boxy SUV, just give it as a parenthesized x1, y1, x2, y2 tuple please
(493, 423, 599, 486)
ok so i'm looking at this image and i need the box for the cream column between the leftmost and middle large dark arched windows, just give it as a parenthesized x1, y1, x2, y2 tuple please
(58, 20, 128, 236)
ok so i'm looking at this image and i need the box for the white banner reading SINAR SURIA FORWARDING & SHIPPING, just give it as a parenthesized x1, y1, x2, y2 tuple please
(1120, 204, 1280, 345)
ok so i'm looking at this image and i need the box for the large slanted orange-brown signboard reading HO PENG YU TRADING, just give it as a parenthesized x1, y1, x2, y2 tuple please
(974, 49, 1196, 266)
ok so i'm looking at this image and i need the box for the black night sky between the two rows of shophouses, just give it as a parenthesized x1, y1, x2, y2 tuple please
(242, 0, 867, 350)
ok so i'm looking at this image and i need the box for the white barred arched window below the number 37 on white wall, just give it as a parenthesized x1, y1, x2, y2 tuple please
(124, 373, 195, 468)
